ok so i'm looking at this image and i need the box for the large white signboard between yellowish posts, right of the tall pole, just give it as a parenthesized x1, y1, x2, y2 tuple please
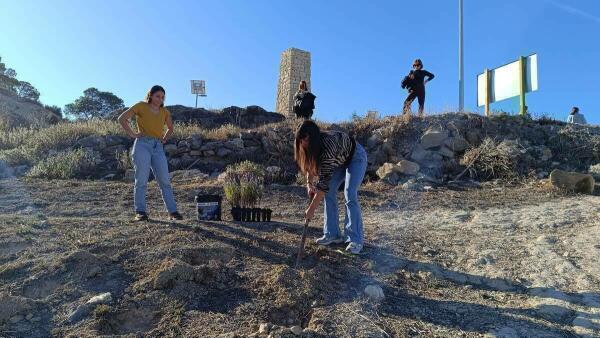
(477, 54, 538, 106)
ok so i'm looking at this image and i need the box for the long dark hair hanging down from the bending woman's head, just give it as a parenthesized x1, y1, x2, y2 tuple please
(294, 120, 321, 176)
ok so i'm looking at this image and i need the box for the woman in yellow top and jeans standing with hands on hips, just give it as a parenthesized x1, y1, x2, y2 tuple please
(119, 86, 183, 221)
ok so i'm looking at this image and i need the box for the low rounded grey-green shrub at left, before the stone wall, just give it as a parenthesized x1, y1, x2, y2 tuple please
(27, 149, 96, 179)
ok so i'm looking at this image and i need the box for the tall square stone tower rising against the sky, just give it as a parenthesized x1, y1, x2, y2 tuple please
(275, 48, 311, 116)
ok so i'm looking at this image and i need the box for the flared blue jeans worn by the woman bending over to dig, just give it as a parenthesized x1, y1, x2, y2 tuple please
(323, 143, 367, 244)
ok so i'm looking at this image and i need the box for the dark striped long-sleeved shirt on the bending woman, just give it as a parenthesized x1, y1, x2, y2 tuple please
(316, 131, 356, 192)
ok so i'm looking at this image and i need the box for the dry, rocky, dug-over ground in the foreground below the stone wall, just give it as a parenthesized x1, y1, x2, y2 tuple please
(0, 177, 600, 337)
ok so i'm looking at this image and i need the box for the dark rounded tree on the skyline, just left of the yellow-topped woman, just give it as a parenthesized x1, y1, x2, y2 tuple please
(65, 88, 125, 119)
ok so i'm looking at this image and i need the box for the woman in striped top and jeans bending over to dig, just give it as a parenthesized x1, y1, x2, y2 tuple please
(294, 120, 367, 254)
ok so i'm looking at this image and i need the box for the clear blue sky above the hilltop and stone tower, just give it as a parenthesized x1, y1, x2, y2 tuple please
(0, 0, 600, 123)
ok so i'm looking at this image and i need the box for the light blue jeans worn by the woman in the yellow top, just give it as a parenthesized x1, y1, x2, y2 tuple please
(131, 137, 177, 213)
